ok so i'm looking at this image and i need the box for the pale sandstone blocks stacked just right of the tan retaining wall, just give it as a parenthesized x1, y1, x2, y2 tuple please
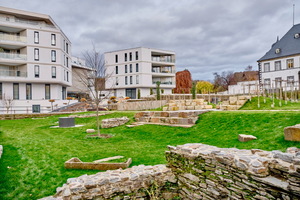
(163, 99, 212, 111)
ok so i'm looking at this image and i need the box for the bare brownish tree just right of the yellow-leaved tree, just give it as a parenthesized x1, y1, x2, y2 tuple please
(213, 71, 235, 92)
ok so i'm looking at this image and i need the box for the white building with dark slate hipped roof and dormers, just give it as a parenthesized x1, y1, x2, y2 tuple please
(258, 24, 300, 91)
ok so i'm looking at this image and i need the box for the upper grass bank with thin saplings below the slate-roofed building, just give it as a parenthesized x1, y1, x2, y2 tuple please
(240, 97, 300, 110)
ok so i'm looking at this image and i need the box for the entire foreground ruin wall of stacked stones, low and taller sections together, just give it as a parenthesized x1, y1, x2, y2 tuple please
(43, 144, 300, 200)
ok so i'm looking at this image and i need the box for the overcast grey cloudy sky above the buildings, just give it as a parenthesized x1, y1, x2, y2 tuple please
(0, 0, 300, 80)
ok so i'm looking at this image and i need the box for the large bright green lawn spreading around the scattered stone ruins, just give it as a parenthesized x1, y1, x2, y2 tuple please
(0, 111, 300, 200)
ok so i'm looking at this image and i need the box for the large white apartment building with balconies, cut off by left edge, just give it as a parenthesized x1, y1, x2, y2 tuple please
(0, 7, 72, 113)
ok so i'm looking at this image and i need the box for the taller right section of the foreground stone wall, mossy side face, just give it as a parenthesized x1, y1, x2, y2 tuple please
(167, 144, 300, 200)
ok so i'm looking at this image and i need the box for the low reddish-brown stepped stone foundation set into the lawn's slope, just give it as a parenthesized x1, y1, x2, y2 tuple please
(134, 111, 208, 125)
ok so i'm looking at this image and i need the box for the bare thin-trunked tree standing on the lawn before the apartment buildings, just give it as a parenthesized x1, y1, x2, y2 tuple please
(74, 45, 111, 137)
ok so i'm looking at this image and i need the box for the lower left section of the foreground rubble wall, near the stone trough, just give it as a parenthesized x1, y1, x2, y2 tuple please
(38, 165, 177, 200)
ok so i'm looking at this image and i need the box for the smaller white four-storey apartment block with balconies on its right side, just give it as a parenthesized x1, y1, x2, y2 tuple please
(104, 47, 176, 99)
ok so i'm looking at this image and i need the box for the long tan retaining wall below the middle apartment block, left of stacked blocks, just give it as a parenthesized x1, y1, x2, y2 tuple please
(108, 100, 167, 111)
